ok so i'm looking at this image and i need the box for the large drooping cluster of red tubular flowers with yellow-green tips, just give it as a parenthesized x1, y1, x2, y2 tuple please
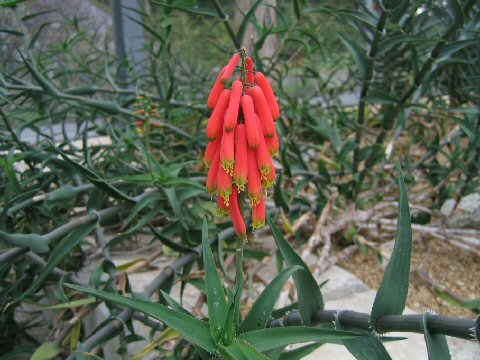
(204, 51, 280, 238)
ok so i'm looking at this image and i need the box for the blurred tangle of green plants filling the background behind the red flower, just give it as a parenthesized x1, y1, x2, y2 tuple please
(0, 0, 480, 356)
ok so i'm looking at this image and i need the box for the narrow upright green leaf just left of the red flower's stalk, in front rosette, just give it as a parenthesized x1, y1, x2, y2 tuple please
(202, 219, 228, 343)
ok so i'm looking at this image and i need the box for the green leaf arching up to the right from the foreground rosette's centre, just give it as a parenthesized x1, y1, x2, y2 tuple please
(238, 265, 303, 334)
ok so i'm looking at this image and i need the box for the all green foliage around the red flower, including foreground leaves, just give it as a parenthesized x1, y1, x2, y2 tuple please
(0, 0, 480, 359)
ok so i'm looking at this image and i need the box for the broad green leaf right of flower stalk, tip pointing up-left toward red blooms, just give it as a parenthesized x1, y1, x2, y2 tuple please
(267, 215, 324, 325)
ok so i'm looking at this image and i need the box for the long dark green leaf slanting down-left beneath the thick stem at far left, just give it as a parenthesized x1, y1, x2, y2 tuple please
(12, 222, 97, 303)
